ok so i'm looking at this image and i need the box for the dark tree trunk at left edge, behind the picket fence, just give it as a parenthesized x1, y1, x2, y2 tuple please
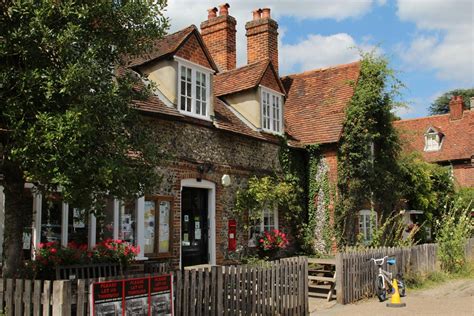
(3, 162, 31, 278)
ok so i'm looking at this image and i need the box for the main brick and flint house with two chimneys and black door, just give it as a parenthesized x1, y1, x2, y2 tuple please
(0, 4, 366, 267)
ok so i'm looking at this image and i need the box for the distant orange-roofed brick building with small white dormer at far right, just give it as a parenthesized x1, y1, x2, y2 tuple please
(394, 96, 474, 188)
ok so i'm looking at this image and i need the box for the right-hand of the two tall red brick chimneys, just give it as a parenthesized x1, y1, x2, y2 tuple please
(245, 8, 278, 72)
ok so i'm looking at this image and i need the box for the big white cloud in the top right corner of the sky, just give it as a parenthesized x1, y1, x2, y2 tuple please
(397, 0, 474, 84)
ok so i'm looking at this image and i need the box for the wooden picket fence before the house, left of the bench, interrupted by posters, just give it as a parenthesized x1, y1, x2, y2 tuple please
(0, 257, 308, 316)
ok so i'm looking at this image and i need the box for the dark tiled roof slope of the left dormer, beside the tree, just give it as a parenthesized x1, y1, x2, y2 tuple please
(127, 25, 197, 67)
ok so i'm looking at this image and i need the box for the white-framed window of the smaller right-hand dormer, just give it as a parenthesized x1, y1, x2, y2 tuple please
(261, 87, 283, 134)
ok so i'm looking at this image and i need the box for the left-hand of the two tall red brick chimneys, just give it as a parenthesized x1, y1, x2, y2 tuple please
(201, 3, 236, 71)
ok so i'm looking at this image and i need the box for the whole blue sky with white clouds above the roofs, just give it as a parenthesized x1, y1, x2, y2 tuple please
(166, 0, 474, 118)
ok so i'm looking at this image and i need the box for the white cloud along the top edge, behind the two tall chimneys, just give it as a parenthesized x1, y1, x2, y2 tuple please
(166, 0, 385, 65)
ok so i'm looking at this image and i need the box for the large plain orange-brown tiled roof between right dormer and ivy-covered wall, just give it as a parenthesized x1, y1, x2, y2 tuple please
(282, 62, 360, 144)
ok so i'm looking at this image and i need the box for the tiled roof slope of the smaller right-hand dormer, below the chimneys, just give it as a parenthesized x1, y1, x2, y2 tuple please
(214, 60, 284, 96)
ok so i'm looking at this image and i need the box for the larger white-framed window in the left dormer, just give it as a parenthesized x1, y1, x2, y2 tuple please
(175, 57, 212, 120)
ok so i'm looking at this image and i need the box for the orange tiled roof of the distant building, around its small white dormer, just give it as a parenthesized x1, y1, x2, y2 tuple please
(394, 110, 474, 162)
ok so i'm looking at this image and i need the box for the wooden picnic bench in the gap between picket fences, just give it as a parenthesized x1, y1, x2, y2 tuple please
(308, 258, 336, 302)
